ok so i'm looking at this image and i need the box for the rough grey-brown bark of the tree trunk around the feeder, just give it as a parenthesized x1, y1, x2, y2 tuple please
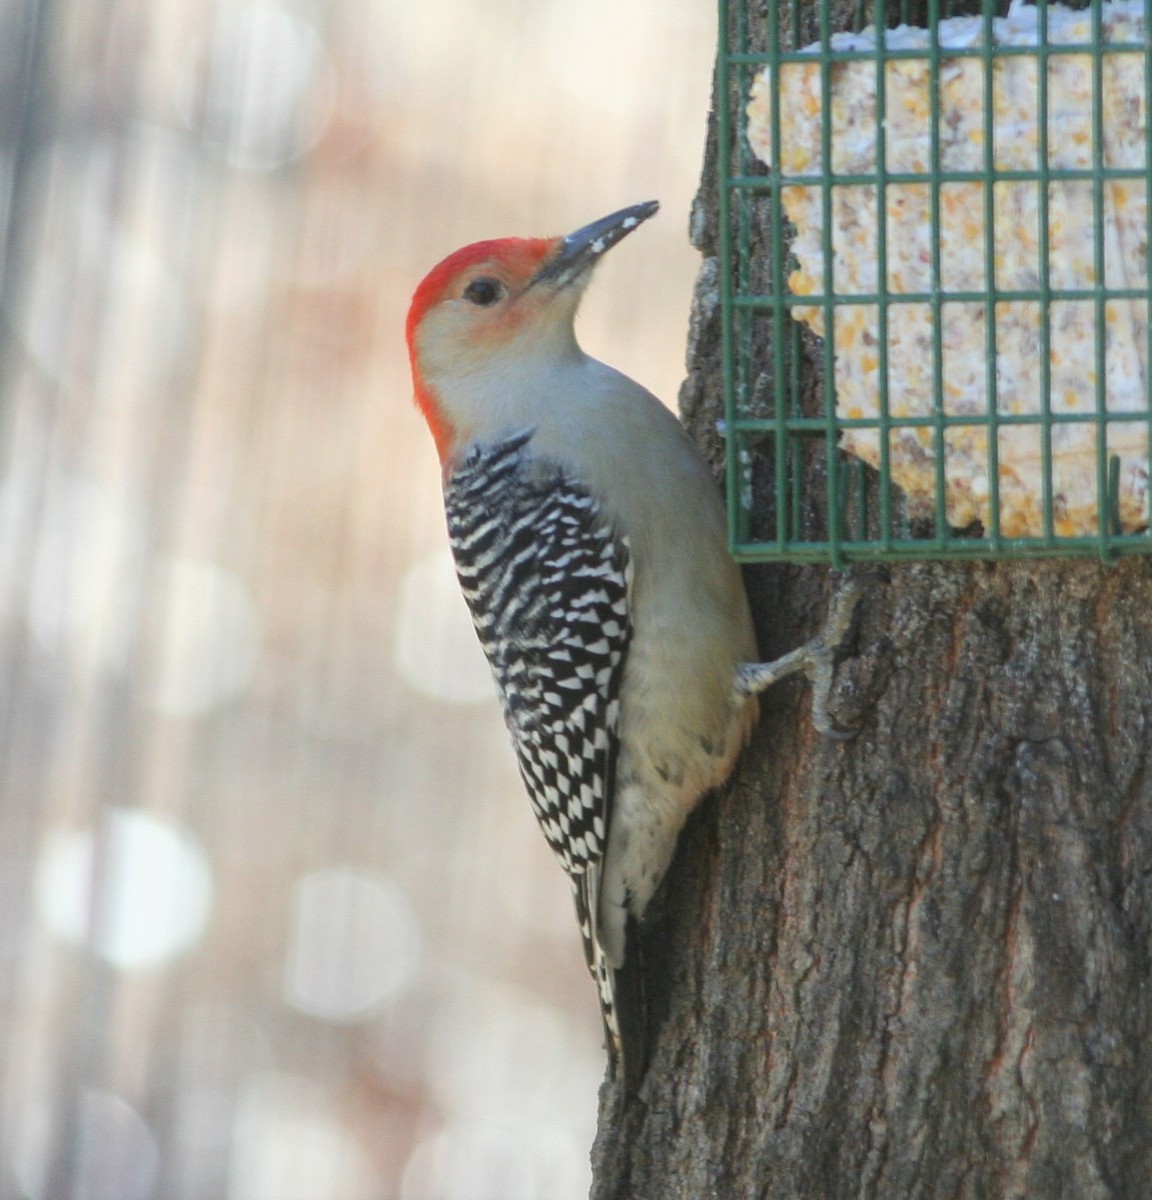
(593, 4, 1152, 1200)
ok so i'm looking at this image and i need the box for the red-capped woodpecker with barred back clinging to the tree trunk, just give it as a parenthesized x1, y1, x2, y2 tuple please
(407, 202, 851, 1087)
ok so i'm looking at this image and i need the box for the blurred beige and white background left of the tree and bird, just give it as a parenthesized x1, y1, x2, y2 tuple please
(0, 0, 714, 1200)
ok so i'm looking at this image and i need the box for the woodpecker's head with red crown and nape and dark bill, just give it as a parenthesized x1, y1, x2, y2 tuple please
(407, 200, 659, 462)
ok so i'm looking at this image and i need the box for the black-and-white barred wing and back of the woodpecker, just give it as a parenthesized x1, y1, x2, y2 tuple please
(445, 433, 631, 1056)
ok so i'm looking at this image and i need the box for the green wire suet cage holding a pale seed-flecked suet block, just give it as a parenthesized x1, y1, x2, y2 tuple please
(719, 0, 1152, 564)
